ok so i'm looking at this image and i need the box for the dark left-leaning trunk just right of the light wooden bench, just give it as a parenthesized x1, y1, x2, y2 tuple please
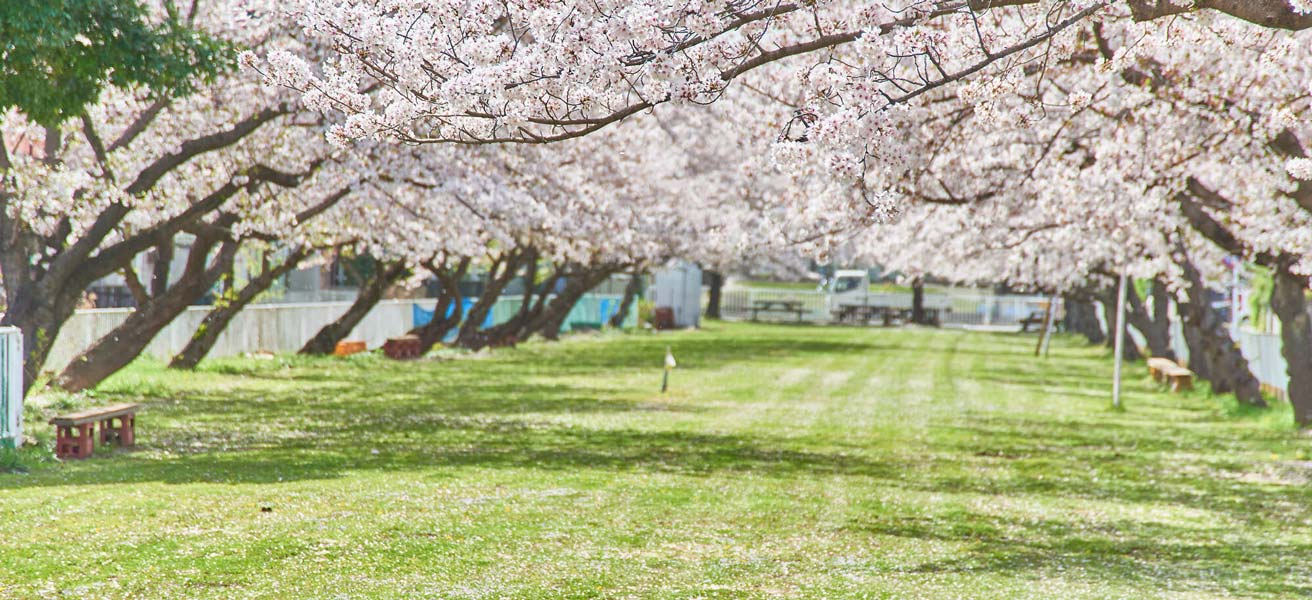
(1176, 249, 1266, 407)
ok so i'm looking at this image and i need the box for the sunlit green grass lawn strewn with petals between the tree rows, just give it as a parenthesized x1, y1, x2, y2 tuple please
(0, 323, 1312, 599)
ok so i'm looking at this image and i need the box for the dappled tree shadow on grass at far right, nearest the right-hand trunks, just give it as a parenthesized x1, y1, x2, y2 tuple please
(904, 415, 1312, 525)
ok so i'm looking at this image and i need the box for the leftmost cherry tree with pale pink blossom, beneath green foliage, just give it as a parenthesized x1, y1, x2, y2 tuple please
(0, 3, 348, 389)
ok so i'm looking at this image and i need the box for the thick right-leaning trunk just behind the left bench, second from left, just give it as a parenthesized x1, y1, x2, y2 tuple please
(54, 239, 240, 391)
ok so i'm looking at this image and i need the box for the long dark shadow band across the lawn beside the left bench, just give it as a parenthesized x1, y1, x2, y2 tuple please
(0, 415, 907, 488)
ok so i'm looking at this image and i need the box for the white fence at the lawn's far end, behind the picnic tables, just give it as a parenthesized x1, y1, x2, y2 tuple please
(720, 289, 1048, 326)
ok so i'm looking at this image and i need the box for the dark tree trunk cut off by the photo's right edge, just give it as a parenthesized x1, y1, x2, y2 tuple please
(1271, 260, 1312, 427)
